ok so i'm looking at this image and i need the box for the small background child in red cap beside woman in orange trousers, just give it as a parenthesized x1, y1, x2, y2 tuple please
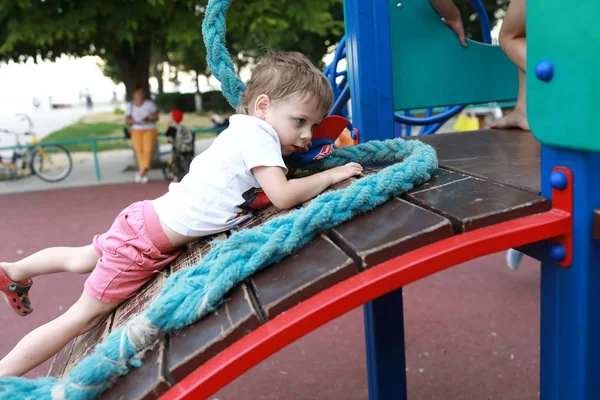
(165, 110, 195, 182)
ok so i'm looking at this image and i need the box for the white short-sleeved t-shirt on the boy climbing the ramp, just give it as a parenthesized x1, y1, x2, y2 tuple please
(154, 114, 287, 236)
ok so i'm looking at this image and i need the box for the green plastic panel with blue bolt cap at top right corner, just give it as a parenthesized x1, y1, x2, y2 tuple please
(527, 0, 600, 151)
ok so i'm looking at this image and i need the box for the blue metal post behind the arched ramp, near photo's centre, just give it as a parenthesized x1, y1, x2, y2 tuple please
(344, 0, 406, 400)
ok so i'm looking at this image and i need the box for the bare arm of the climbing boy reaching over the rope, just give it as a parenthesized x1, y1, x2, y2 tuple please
(252, 163, 362, 208)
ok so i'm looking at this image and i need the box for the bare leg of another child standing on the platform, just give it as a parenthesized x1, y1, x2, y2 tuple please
(490, 0, 529, 130)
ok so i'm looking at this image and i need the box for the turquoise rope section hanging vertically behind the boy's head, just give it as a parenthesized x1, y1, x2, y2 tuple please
(202, 0, 244, 109)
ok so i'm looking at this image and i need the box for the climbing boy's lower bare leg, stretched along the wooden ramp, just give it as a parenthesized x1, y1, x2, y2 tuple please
(0, 292, 119, 376)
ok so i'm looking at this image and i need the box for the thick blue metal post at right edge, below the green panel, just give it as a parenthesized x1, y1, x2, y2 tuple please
(540, 145, 600, 400)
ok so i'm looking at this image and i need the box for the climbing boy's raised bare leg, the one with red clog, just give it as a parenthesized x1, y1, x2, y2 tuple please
(0, 244, 99, 282)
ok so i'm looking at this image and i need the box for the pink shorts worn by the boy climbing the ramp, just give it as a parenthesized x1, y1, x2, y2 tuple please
(85, 200, 181, 303)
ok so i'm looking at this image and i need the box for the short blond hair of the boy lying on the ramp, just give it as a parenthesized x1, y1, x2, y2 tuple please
(242, 52, 333, 114)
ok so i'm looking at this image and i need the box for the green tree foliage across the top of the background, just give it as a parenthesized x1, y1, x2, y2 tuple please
(0, 0, 508, 100)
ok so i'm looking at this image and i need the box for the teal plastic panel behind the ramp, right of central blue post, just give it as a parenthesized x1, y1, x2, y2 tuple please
(389, 0, 518, 110)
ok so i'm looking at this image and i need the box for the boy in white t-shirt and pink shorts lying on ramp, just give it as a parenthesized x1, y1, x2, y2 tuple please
(0, 53, 362, 376)
